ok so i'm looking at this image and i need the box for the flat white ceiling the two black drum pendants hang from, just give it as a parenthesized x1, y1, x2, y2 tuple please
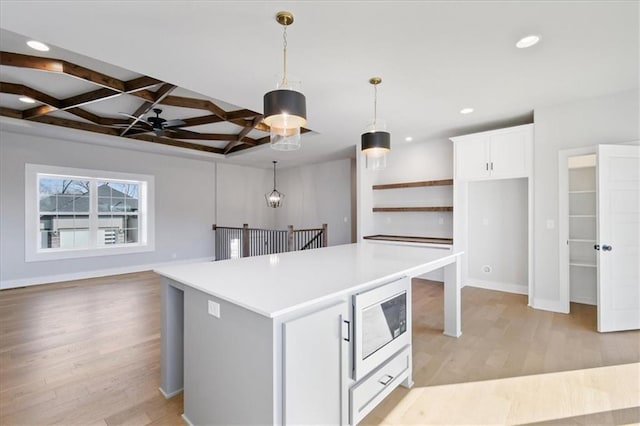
(0, 0, 640, 168)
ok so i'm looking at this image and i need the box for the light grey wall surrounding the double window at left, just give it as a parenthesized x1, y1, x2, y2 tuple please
(0, 131, 215, 288)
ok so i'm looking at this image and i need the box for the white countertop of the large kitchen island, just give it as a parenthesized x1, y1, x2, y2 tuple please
(155, 242, 459, 318)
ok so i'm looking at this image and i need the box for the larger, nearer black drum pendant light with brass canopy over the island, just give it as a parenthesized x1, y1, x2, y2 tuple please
(264, 12, 307, 151)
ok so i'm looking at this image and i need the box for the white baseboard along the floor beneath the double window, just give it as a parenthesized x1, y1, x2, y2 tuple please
(0, 257, 214, 290)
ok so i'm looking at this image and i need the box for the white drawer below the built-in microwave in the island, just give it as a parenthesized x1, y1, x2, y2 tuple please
(349, 345, 411, 425)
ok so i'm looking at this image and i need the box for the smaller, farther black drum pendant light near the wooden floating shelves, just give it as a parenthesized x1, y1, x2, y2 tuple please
(361, 77, 391, 170)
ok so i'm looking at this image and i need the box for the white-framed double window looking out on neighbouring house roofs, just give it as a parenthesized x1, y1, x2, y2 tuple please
(25, 164, 154, 261)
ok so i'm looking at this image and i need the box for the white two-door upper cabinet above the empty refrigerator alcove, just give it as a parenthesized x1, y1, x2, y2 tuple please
(451, 124, 533, 180)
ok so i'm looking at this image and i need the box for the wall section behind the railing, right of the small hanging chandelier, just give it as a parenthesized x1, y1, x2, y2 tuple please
(276, 158, 353, 246)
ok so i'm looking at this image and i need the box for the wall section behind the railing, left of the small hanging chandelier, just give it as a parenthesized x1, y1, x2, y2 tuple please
(216, 163, 276, 229)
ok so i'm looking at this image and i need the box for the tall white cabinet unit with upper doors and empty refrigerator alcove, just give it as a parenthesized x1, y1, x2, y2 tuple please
(451, 124, 533, 300)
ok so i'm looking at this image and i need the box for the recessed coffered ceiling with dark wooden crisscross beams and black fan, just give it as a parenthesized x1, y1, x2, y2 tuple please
(0, 29, 307, 155)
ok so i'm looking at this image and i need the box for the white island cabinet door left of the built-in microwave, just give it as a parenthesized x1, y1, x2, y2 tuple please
(283, 302, 349, 425)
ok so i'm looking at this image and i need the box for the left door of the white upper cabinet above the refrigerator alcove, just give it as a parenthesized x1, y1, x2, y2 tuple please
(455, 136, 489, 180)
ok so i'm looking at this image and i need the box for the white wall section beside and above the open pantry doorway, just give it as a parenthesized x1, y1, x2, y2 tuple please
(533, 90, 640, 311)
